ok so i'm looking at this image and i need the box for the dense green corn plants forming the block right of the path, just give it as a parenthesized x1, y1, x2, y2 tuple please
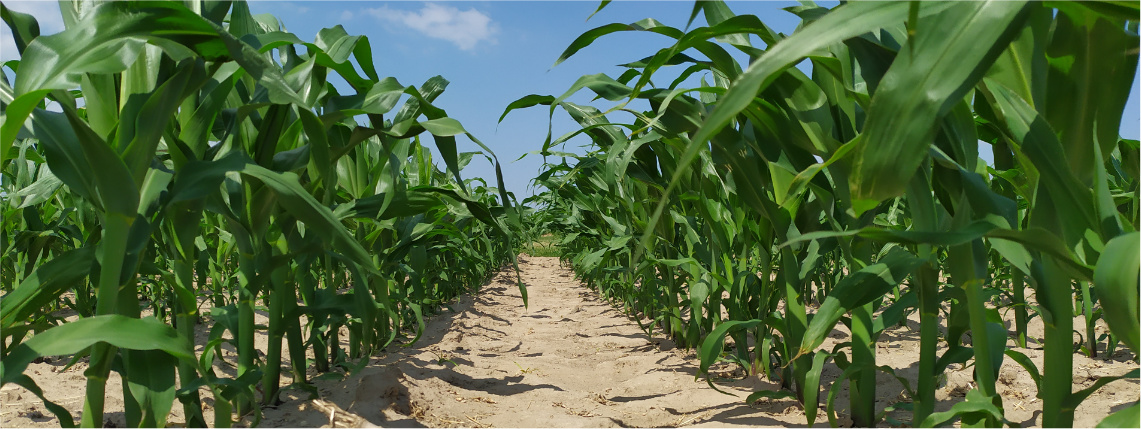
(520, 2, 1139, 427)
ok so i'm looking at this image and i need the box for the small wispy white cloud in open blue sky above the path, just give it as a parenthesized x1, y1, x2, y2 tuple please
(365, 3, 499, 50)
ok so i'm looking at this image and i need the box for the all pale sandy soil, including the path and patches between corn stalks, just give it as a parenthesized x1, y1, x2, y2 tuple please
(0, 257, 1141, 427)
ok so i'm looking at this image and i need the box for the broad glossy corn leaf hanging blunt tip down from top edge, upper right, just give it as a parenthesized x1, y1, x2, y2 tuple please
(850, 1, 1027, 207)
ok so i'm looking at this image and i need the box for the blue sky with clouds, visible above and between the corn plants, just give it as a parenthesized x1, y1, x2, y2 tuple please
(0, 1, 1141, 200)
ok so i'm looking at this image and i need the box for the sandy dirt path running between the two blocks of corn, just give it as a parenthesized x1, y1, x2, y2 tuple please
(261, 257, 804, 427)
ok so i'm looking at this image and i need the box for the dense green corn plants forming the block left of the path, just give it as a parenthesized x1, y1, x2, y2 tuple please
(0, 1, 521, 427)
